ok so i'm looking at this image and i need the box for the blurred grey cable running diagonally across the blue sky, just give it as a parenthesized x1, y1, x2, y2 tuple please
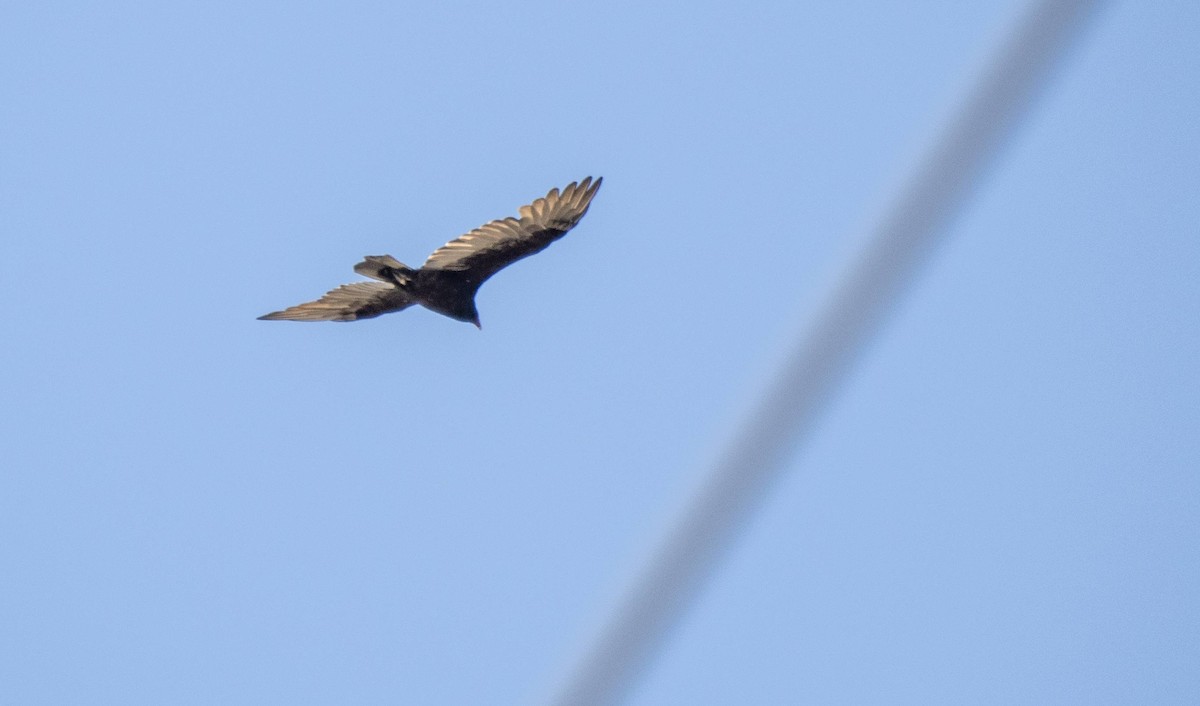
(551, 0, 1099, 706)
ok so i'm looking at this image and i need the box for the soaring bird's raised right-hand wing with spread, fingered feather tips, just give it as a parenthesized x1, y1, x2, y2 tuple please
(422, 177, 604, 286)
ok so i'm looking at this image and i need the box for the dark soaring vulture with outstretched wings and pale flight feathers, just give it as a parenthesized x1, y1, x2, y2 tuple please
(258, 177, 604, 327)
